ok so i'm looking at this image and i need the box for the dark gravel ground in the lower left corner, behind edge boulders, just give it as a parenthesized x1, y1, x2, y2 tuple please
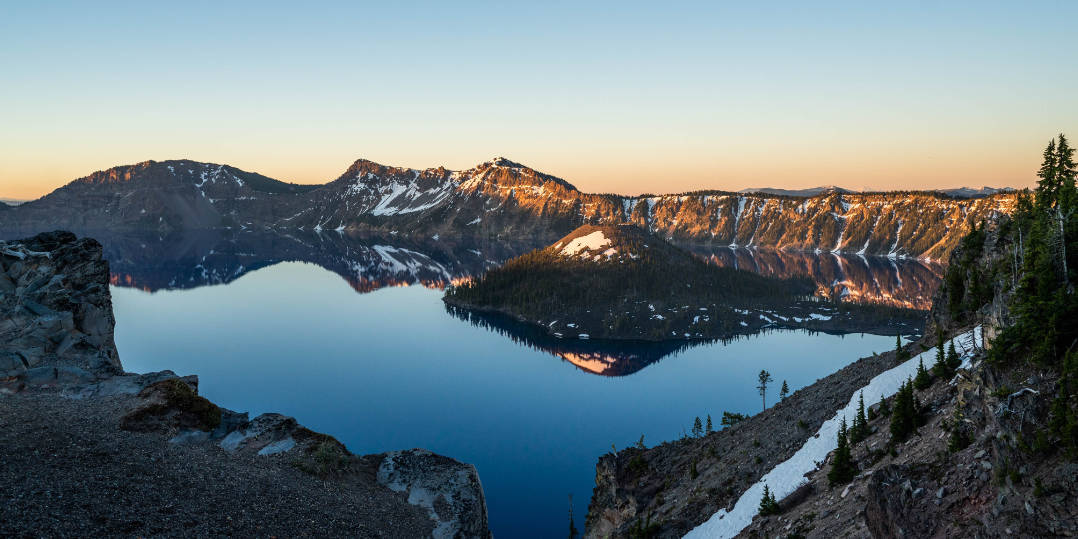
(0, 389, 433, 538)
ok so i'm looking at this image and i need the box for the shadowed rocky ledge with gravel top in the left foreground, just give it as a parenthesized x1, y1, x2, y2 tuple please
(0, 232, 490, 538)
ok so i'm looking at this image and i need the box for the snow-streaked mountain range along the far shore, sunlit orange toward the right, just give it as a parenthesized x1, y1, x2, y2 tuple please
(0, 157, 1015, 260)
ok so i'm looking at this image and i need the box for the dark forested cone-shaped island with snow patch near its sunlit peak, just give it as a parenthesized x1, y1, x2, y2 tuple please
(444, 225, 921, 341)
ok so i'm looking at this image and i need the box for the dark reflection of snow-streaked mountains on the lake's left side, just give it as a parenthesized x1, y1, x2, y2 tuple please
(94, 231, 537, 293)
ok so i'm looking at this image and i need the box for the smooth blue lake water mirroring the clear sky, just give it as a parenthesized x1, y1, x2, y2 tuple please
(106, 259, 901, 537)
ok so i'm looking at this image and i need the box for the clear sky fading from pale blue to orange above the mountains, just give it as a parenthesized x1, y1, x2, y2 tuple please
(0, 1, 1078, 198)
